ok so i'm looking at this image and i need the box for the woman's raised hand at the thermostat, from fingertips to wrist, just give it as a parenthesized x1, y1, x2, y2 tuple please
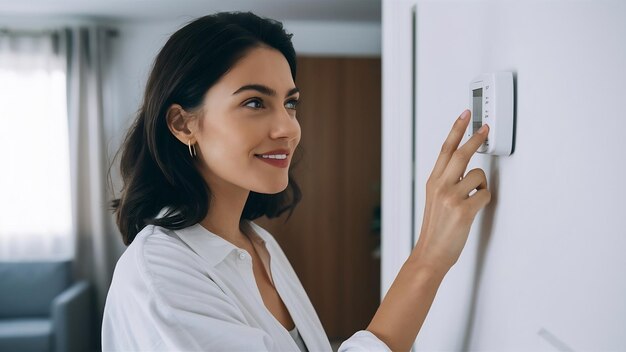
(411, 110, 491, 273)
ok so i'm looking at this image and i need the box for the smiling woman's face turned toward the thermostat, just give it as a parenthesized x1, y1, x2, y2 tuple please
(194, 47, 300, 194)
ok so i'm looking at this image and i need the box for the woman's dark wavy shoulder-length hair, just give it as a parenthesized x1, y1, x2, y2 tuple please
(109, 12, 302, 245)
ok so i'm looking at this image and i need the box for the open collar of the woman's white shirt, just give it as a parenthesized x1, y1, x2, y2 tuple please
(174, 220, 265, 266)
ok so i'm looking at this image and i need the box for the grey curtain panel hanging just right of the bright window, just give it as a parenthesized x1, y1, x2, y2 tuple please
(64, 27, 121, 336)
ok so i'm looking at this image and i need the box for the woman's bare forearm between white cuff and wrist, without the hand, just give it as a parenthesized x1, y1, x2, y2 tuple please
(367, 253, 446, 351)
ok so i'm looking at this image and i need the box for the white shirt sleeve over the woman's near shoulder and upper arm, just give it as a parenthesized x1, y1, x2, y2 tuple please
(102, 233, 274, 351)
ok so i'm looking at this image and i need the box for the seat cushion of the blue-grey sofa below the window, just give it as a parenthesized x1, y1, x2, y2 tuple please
(0, 318, 52, 352)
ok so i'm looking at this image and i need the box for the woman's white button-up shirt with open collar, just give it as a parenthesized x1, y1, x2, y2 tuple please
(102, 221, 389, 352)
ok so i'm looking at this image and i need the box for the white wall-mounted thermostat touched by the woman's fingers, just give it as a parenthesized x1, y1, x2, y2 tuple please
(466, 72, 513, 155)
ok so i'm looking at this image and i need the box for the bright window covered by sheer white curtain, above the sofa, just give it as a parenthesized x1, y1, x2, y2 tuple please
(0, 32, 73, 260)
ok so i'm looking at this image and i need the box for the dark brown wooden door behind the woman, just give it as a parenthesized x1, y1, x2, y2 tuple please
(257, 57, 381, 340)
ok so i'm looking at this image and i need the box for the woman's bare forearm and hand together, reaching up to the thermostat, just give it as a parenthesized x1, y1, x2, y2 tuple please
(367, 110, 491, 351)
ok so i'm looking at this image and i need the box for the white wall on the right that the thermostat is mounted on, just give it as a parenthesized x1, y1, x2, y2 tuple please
(383, 1, 626, 351)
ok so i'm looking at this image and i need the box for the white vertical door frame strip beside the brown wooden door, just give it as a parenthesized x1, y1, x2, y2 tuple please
(380, 0, 414, 299)
